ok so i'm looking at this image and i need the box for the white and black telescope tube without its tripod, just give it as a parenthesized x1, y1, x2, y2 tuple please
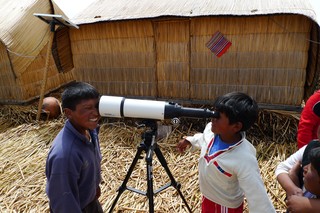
(99, 96, 219, 120)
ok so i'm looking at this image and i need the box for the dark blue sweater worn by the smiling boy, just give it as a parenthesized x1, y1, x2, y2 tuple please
(46, 121, 101, 213)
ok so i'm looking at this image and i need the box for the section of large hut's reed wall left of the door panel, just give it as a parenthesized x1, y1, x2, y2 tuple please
(70, 21, 157, 97)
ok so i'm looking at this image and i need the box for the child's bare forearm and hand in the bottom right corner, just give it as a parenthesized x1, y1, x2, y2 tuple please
(286, 195, 320, 213)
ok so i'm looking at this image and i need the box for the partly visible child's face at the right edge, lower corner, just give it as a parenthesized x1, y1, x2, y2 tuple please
(303, 163, 320, 195)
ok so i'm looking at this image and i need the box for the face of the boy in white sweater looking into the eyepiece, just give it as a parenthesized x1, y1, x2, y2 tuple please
(211, 112, 242, 142)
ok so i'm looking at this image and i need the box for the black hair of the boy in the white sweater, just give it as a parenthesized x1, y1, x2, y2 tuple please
(214, 92, 259, 131)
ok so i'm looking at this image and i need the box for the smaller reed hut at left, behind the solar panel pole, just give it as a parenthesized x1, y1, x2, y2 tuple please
(0, 0, 74, 103)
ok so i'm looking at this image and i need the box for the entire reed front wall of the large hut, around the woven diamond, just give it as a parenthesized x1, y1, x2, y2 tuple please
(70, 15, 311, 106)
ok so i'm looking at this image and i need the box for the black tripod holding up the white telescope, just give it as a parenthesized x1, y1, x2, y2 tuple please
(109, 120, 192, 213)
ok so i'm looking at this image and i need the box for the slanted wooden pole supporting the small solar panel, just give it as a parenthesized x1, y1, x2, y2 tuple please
(37, 30, 54, 121)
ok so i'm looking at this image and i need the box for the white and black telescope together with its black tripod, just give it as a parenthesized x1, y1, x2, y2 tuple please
(98, 96, 208, 213)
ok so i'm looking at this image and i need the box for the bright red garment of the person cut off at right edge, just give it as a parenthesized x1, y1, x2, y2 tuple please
(297, 90, 320, 149)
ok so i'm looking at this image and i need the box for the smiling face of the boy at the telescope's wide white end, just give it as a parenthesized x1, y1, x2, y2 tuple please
(65, 99, 100, 134)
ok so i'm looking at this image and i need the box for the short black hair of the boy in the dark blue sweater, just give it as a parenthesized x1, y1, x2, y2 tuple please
(61, 82, 100, 110)
